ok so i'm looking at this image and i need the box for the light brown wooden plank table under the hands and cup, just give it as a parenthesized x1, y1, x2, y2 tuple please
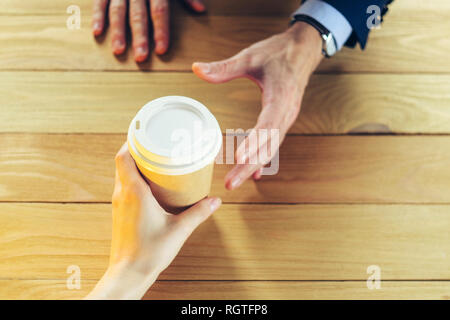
(0, 0, 450, 299)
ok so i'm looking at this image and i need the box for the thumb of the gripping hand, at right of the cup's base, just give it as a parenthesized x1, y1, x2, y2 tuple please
(175, 198, 222, 234)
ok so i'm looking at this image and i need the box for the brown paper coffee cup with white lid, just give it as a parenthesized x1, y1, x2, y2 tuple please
(128, 96, 222, 213)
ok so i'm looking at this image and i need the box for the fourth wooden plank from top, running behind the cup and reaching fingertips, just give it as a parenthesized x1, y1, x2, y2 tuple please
(0, 134, 450, 203)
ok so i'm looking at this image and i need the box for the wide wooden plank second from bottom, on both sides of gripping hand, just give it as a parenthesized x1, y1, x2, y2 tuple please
(0, 203, 450, 280)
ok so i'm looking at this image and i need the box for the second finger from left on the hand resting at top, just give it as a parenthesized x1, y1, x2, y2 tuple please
(109, 0, 127, 55)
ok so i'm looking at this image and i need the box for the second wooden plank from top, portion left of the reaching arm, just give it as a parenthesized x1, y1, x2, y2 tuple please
(0, 16, 286, 71)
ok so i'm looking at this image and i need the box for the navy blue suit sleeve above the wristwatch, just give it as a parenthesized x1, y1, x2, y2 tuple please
(302, 0, 393, 49)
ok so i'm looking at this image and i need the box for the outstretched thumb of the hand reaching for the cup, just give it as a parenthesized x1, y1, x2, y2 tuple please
(192, 53, 248, 83)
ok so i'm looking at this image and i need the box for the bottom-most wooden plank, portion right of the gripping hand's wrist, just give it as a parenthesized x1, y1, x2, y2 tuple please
(144, 281, 450, 300)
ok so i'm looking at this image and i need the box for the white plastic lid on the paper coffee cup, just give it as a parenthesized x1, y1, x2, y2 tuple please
(128, 96, 222, 175)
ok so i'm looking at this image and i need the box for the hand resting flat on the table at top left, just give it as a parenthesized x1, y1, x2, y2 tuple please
(92, 0, 205, 62)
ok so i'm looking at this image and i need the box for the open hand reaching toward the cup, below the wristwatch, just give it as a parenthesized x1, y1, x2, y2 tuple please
(192, 22, 322, 189)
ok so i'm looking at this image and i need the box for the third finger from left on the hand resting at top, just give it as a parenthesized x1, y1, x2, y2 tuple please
(130, 0, 149, 62)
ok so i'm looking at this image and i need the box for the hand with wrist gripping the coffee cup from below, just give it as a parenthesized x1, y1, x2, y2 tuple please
(86, 145, 221, 299)
